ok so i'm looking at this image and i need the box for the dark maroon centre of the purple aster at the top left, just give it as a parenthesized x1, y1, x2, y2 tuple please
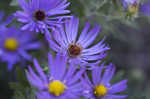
(34, 10, 46, 21)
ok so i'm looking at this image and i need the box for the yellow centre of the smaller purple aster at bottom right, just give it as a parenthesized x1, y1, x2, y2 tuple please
(94, 85, 107, 97)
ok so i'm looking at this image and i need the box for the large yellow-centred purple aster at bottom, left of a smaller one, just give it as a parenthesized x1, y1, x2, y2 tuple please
(27, 54, 84, 99)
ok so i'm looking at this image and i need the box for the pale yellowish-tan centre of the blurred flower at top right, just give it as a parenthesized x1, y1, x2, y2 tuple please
(128, 3, 139, 14)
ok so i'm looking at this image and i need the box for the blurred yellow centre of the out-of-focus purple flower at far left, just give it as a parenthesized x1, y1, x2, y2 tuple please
(4, 38, 18, 51)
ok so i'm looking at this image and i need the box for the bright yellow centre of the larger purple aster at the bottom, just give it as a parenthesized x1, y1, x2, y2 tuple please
(48, 80, 66, 96)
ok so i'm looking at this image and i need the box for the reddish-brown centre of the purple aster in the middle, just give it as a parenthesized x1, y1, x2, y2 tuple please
(68, 44, 82, 57)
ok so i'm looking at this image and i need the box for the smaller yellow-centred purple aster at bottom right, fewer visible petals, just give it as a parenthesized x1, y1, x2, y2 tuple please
(83, 64, 127, 99)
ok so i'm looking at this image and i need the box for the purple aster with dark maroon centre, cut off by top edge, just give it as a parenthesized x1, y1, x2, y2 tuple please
(15, 0, 70, 33)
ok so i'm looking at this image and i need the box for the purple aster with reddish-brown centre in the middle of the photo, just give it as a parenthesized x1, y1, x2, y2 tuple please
(46, 17, 109, 65)
